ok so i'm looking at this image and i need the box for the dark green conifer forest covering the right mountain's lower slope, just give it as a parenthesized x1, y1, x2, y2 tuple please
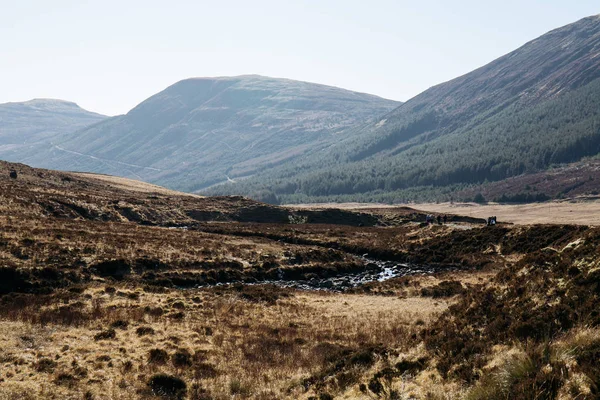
(210, 80, 600, 202)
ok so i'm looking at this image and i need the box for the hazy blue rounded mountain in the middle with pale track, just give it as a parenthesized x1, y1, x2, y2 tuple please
(8, 75, 400, 191)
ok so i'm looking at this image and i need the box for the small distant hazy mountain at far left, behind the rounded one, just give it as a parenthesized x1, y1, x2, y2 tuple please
(0, 99, 107, 150)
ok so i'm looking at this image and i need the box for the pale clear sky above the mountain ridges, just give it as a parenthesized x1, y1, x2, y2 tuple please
(0, 0, 600, 115)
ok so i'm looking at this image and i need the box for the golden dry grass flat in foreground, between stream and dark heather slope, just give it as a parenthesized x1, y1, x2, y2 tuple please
(0, 284, 458, 399)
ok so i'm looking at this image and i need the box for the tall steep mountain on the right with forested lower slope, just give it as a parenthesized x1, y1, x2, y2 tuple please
(213, 16, 600, 202)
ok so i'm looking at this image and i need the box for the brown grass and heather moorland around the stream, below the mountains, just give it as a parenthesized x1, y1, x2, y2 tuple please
(0, 164, 600, 400)
